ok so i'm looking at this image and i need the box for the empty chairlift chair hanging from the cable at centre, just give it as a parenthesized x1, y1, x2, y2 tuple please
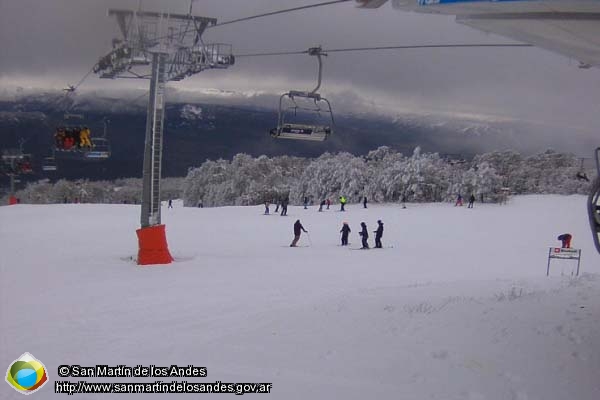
(270, 46, 335, 142)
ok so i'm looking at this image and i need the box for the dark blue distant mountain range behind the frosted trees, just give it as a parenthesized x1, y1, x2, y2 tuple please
(0, 92, 592, 186)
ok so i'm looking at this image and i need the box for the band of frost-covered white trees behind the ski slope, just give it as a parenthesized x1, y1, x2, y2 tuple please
(8, 147, 590, 207)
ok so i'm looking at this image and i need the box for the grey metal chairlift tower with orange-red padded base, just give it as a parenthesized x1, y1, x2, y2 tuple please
(94, 9, 234, 265)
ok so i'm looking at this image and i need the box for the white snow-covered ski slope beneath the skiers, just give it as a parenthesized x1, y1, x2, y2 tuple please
(0, 196, 600, 400)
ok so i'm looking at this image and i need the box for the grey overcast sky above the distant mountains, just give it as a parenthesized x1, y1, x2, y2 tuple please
(0, 0, 600, 150)
